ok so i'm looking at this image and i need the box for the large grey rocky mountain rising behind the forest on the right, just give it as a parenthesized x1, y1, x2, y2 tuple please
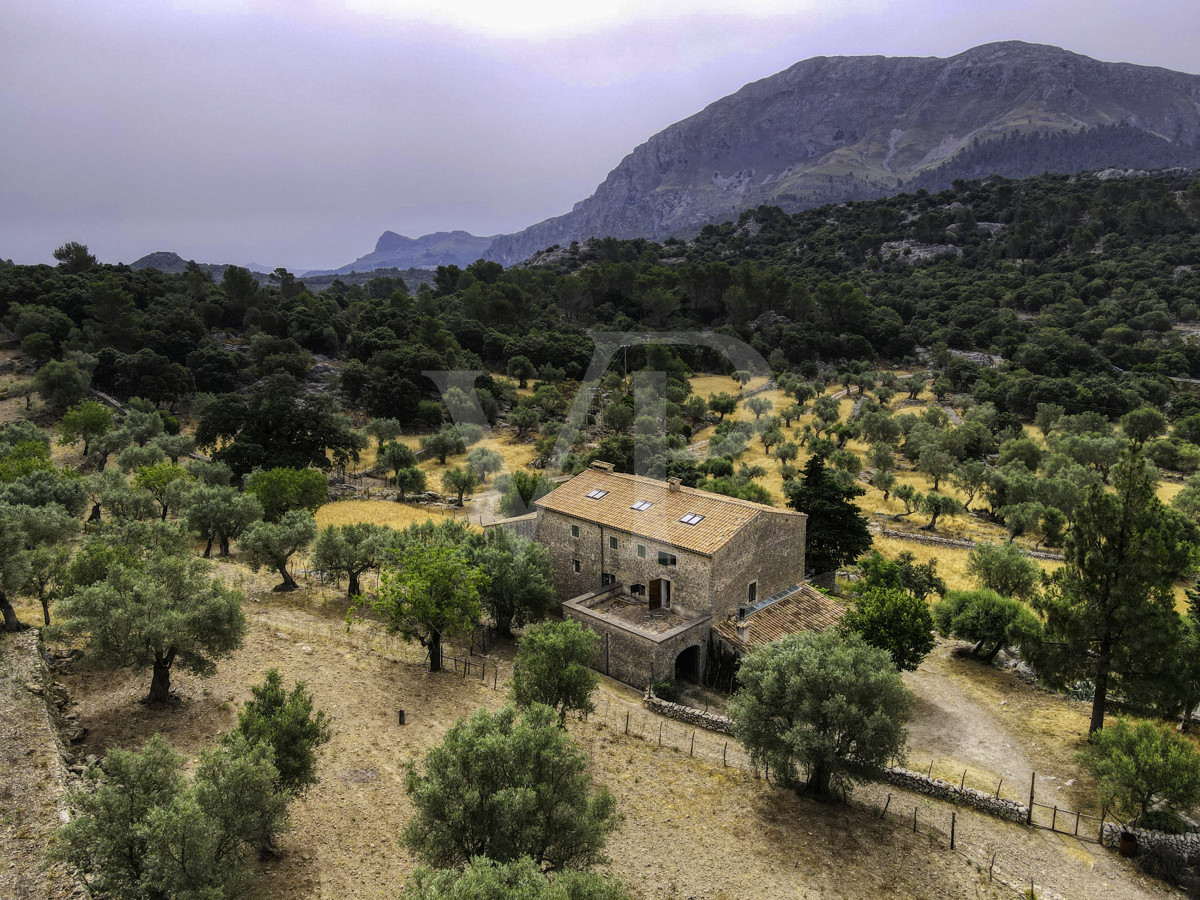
(487, 41, 1200, 265)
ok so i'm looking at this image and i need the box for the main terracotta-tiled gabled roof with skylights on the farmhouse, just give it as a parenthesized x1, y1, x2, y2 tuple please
(535, 463, 803, 556)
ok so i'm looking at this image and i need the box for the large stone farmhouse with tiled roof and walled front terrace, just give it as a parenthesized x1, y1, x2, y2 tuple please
(530, 462, 840, 688)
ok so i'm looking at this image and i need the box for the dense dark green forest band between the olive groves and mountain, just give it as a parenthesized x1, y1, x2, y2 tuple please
(7, 172, 1200, 434)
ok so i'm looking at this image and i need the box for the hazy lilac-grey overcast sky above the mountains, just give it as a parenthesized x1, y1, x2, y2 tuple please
(0, 0, 1200, 271)
